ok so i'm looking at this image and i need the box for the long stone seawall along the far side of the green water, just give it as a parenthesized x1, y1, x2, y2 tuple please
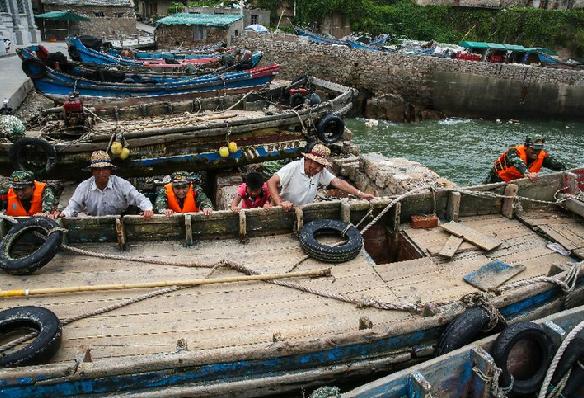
(234, 34, 584, 121)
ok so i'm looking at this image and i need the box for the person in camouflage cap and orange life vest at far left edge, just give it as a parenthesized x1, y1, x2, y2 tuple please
(0, 170, 58, 218)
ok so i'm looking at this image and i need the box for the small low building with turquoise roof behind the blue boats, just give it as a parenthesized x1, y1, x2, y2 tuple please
(154, 13, 243, 48)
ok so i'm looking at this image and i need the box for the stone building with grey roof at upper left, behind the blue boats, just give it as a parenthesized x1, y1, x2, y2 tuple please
(41, 0, 137, 39)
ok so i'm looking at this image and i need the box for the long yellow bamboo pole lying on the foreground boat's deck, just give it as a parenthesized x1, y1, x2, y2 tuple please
(0, 268, 331, 298)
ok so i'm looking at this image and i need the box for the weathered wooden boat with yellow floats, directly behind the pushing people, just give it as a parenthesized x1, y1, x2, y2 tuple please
(0, 77, 356, 179)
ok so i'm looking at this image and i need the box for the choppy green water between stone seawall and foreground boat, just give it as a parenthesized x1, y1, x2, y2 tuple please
(347, 119, 584, 185)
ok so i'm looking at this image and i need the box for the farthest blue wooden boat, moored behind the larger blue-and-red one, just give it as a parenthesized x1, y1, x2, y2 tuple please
(66, 36, 223, 67)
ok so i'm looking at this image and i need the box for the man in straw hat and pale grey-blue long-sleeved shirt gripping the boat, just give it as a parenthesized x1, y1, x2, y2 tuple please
(61, 151, 154, 219)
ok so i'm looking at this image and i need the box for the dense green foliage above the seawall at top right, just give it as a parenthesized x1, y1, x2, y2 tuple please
(351, 0, 584, 55)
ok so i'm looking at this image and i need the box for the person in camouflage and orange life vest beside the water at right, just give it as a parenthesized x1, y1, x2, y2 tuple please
(485, 135, 566, 184)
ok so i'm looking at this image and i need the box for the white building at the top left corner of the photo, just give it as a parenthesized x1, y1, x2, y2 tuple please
(0, 0, 41, 45)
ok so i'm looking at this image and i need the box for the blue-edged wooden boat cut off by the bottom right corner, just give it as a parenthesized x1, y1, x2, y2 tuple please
(342, 306, 584, 398)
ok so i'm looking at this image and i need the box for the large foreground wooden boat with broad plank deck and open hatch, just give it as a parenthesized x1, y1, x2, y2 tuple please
(0, 164, 584, 397)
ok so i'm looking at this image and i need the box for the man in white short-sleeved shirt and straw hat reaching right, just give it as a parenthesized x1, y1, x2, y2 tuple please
(268, 144, 374, 211)
